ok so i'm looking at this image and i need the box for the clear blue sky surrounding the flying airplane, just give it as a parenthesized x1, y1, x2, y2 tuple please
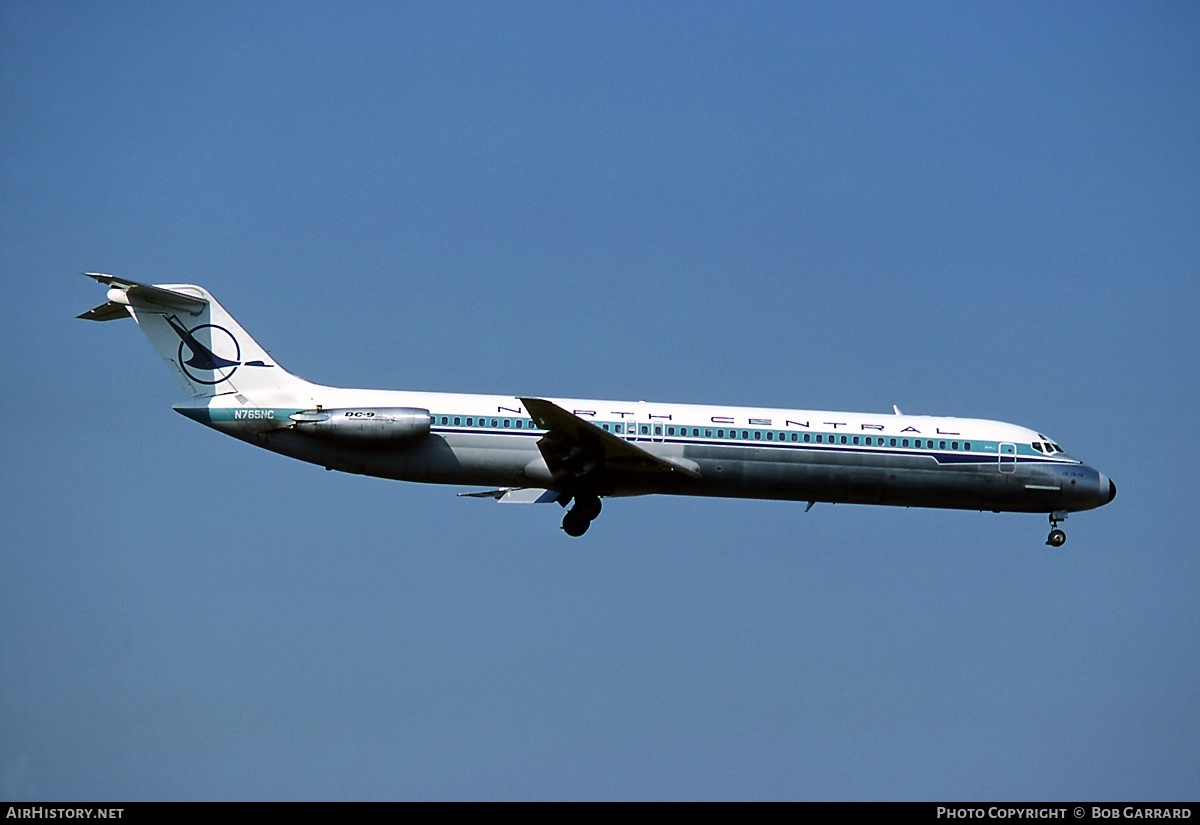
(0, 0, 1200, 800)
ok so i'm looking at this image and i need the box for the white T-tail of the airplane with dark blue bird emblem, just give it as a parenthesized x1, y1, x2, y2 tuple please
(79, 272, 313, 404)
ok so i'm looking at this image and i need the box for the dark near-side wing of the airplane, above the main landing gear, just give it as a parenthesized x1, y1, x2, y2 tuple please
(521, 398, 701, 481)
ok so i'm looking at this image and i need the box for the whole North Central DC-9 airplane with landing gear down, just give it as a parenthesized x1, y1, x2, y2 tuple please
(79, 272, 1117, 547)
